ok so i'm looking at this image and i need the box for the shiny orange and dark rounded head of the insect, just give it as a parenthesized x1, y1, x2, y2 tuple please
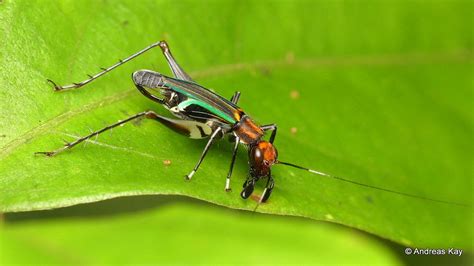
(249, 140, 278, 178)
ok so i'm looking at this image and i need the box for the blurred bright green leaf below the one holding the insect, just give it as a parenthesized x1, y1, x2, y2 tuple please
(0, 199, 401, 265)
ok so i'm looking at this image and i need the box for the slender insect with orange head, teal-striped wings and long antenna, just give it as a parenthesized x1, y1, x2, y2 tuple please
(36, 41, 465, 206)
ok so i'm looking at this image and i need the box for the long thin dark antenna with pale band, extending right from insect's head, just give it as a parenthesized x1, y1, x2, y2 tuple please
(276, 161, 471, 207)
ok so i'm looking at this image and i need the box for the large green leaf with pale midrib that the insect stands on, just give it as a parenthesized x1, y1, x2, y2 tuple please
(0, 1, 473, 249)
